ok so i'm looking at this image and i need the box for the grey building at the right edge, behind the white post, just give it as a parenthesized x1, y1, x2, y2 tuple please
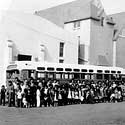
(110, 12, 125, 68)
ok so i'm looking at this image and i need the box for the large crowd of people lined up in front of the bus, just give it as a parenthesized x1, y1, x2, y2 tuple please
(0, 78, 125, 108)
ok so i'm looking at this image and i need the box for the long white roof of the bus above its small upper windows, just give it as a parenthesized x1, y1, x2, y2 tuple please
(7, 61, 125, 74)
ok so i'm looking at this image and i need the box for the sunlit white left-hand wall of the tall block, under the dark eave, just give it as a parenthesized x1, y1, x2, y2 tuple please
(64, 19, 91, 64)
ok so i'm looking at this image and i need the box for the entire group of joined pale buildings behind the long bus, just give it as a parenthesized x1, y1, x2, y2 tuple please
(0, 0, 125, 86)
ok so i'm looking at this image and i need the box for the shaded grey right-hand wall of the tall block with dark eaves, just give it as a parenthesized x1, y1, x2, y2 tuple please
(89, 20, 113, 66)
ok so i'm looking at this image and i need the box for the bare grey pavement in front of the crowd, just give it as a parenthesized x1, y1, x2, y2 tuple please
(0, 102, 125, 125)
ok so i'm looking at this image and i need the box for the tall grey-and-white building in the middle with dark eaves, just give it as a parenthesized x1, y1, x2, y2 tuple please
(35, 0, 115, 66)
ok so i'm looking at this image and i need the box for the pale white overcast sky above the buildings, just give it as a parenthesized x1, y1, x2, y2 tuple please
(0, 0, 125, 14)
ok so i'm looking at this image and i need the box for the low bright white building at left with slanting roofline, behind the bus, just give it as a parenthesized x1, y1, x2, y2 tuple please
(0, 12, 78, 85)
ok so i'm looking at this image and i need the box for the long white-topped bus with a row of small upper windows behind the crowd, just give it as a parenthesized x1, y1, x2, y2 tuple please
(6, 61, 125, 83)
